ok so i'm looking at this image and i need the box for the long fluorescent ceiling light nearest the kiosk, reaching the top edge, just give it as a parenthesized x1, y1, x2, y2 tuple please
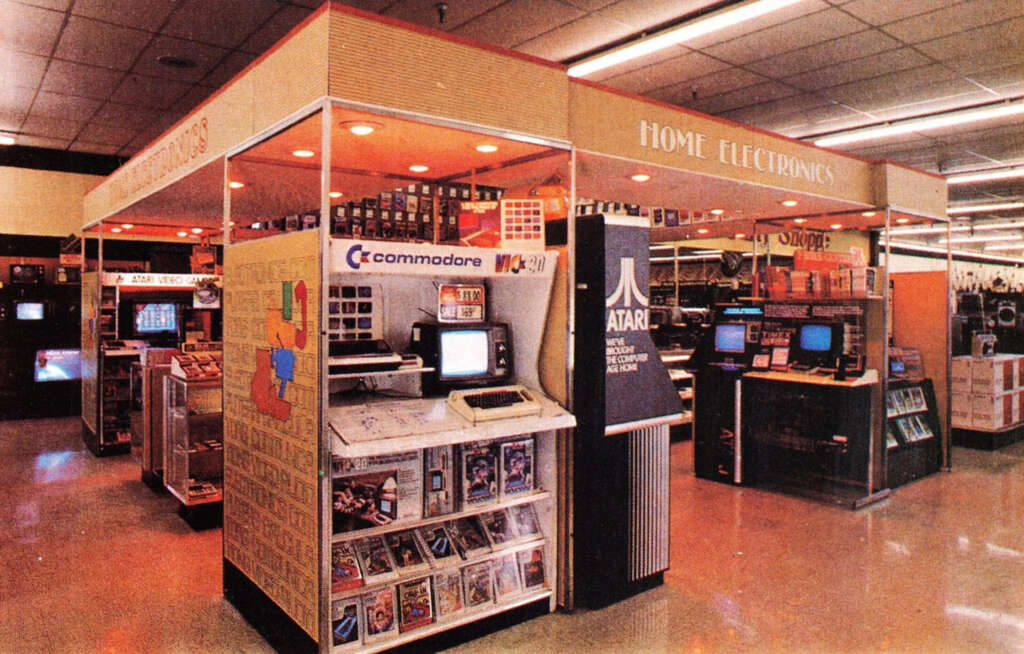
(568, 0, 800, 77)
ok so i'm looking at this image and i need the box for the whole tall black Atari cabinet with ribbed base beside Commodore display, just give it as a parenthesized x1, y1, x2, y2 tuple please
(551, 215, 682, 608)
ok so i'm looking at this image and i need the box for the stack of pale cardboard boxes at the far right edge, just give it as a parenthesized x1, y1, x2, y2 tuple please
(951, 354, 1024, 431)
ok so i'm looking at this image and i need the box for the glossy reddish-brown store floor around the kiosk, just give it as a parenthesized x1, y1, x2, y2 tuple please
(0, 420, 1024, 653)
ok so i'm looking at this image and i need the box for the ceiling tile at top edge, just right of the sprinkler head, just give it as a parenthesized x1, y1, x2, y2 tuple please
(453, 0, 584, 48)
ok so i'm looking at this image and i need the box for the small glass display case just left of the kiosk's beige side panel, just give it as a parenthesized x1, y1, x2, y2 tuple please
(164, 376, 224, 508)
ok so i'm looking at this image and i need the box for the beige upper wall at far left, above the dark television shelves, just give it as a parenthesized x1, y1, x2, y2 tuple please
(0, 166, 103, 236)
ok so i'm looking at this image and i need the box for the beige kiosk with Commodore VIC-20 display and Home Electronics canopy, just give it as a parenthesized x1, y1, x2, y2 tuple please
(77, 4, 944, 652)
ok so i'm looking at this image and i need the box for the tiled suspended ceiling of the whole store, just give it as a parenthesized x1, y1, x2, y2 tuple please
(0, 0, 1024, 247)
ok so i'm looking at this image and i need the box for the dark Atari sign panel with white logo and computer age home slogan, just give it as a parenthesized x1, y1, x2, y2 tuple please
(604, 223, 680, 426)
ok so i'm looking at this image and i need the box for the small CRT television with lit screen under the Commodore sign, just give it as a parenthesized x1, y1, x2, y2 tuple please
(410, 322, 512, 394)
